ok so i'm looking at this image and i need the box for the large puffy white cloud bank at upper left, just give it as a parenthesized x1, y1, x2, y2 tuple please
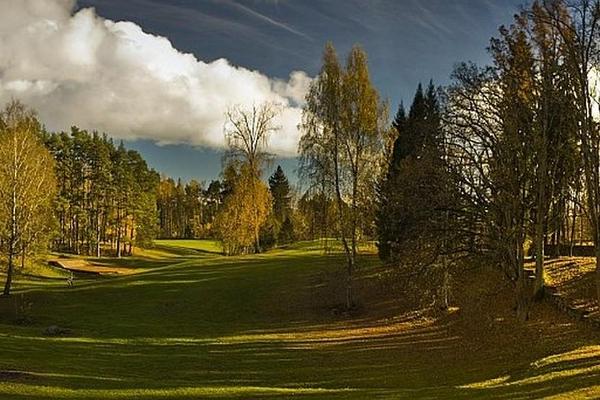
(0, 0, 310, 156)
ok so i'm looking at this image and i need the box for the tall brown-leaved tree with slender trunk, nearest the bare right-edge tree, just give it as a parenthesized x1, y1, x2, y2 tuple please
(516, 2, 579, 297)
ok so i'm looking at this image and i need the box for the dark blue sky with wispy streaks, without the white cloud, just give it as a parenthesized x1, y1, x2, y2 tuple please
(78, 0, 523, 180)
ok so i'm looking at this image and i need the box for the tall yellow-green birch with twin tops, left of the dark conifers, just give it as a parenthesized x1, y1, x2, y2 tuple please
(300, 43, 387, 308)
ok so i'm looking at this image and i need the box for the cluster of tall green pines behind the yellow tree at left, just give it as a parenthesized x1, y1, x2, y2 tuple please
(44, 128, 159, 257)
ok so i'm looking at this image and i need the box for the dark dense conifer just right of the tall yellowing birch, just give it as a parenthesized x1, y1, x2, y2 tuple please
(376, 82, 455, 308)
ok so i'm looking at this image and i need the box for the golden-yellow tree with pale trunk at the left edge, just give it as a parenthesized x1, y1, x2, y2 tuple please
(0, 101, 56, 296)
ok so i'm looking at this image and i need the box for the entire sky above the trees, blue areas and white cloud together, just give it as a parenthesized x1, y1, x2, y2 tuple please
(0, 0, 523, 180)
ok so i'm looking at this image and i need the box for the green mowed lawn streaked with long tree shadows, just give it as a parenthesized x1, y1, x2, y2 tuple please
(0, 241, 600, 399)
